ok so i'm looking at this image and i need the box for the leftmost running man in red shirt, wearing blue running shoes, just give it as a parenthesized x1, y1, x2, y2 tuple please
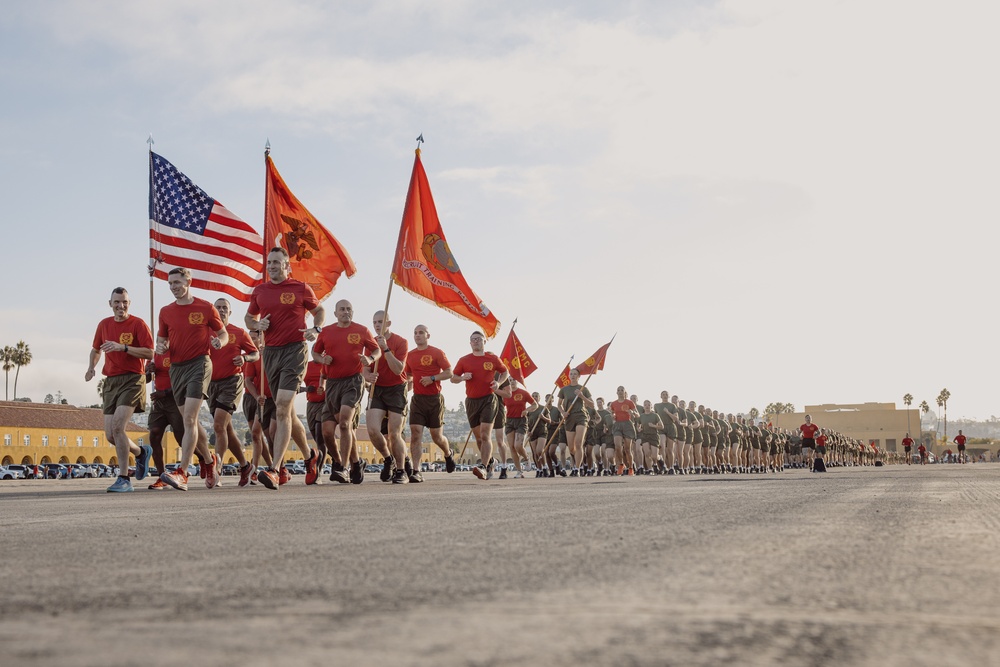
(83, 287, 153, 492)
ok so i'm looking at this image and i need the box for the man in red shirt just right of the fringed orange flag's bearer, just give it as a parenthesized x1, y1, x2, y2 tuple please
(400, 324, 455, 483)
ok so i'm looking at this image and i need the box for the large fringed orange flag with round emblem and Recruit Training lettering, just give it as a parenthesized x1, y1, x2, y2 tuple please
(392, 148, 500, 338)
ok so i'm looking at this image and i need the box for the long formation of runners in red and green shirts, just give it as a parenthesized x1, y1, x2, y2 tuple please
(85, 248, 908, 492)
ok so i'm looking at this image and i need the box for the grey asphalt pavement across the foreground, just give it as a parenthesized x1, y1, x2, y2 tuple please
(0, 464, 1000, 667)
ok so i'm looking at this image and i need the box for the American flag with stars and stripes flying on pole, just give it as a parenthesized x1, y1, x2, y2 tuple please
(149, 151, 264, 301)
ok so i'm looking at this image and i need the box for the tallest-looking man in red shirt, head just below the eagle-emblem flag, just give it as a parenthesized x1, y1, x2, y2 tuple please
(244, 247, 326, 490)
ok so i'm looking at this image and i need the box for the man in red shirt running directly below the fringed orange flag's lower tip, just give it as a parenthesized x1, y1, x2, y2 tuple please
(451, 331, 508, 479)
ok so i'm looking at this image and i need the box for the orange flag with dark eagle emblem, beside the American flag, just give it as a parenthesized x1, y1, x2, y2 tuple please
(264, 154, 357, 301)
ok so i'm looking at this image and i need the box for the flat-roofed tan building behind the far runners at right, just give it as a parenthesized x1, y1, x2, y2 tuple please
(774, 403, 920, 452)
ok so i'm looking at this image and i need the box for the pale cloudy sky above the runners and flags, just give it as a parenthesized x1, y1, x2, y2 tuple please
(0, 0, 1000, 419)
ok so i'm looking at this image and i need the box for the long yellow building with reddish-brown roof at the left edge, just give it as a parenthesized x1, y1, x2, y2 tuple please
(0, 401, 149, 465)
